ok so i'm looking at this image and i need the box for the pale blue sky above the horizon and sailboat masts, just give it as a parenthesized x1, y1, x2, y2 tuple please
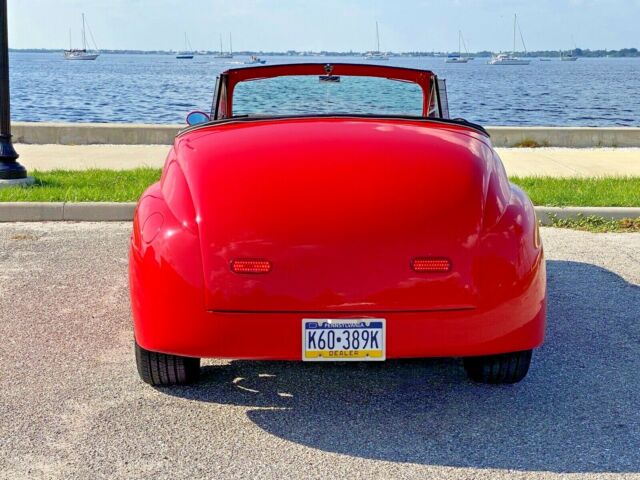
(8, 0, 640, 51)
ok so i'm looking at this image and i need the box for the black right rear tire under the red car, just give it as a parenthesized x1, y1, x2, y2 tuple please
(463, 350, 533, 384)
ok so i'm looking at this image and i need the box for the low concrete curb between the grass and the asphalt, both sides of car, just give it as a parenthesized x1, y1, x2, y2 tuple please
(0, 202, 640, 225)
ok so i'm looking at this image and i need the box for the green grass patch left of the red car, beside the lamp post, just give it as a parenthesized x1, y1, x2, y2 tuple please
(0, 168, 160, 202)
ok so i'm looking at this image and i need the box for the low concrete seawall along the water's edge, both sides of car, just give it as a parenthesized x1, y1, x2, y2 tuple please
(12, 122, 640, 148)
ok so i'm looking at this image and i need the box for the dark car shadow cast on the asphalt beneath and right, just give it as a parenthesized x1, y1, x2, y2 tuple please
(162, 261, 640, 472)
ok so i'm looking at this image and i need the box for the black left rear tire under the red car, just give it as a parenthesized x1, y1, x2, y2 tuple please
(136, 342, 200, 387)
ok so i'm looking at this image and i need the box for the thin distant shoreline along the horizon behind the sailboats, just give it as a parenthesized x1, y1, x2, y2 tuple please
(9, 48, 640, 58)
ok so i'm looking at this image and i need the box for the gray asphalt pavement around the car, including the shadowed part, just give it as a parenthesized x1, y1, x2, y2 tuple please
(0, 223, 640, 479)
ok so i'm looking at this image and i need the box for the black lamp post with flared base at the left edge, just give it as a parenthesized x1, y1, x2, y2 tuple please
(0, 0, 27, 180)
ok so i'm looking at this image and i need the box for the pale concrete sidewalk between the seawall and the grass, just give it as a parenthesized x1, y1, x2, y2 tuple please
(16, 144, 640, 177)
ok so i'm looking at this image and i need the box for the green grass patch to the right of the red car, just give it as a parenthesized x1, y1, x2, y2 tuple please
(511, 177, 640, 207)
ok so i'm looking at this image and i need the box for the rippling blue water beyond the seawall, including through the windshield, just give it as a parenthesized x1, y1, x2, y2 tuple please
(10, 53, 640, 126)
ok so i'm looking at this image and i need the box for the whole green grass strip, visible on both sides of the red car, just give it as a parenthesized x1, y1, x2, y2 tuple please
(0, 168, 640, 207)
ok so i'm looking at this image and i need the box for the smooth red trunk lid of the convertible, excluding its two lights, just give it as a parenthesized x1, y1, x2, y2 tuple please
(178, 119, 486, 313)
